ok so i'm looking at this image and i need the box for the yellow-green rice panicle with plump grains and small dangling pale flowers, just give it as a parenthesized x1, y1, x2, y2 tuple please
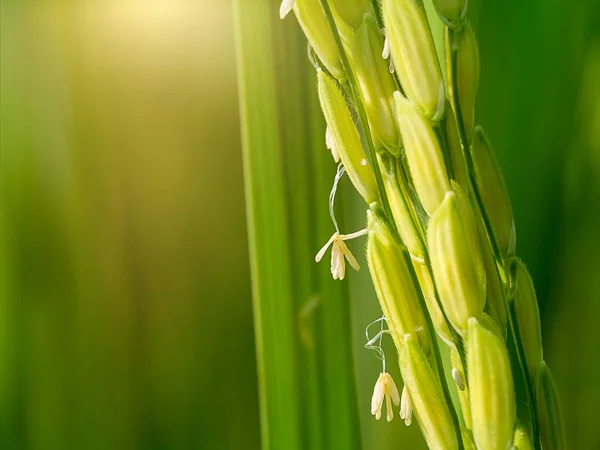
(282, 0, 564, 450)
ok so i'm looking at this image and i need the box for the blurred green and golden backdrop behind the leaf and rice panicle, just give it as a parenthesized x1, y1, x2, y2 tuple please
(0, 0, 600, 450)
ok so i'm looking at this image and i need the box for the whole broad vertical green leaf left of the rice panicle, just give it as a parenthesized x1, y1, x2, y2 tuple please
(234, 0, 361, 450)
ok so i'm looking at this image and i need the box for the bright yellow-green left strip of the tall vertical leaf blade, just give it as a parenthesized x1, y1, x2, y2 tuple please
(234, 0, 302, 450)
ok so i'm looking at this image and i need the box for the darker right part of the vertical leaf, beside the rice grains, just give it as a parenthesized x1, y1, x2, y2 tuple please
(274, 11, 360, 450)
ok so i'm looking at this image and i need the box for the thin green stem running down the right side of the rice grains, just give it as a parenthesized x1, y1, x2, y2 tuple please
(446, 28, 541, 450)
